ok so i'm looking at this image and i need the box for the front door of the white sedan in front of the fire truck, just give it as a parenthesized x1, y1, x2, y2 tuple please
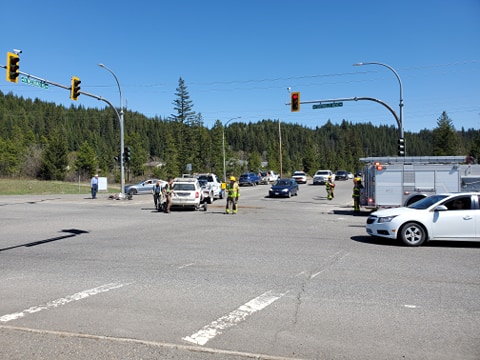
(431, 195, 478, 241)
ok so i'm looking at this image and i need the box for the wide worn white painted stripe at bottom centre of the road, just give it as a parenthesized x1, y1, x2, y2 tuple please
(182, 291, 288, 345)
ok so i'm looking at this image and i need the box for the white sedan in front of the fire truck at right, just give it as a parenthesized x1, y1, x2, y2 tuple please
(366, 193, 480, 246)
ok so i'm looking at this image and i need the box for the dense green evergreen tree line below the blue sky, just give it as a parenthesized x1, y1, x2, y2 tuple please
(0, 78, 480, 182)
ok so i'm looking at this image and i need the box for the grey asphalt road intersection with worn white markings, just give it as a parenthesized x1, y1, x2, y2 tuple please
(0, 181, 480, 360)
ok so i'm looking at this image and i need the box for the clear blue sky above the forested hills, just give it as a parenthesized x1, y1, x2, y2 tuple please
(0, 0, 480, 132)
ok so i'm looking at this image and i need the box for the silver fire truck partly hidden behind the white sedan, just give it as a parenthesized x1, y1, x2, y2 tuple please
(360, 156, 480, 209)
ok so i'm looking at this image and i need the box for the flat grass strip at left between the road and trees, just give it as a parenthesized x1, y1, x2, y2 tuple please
(0, 179, 120, 195)
